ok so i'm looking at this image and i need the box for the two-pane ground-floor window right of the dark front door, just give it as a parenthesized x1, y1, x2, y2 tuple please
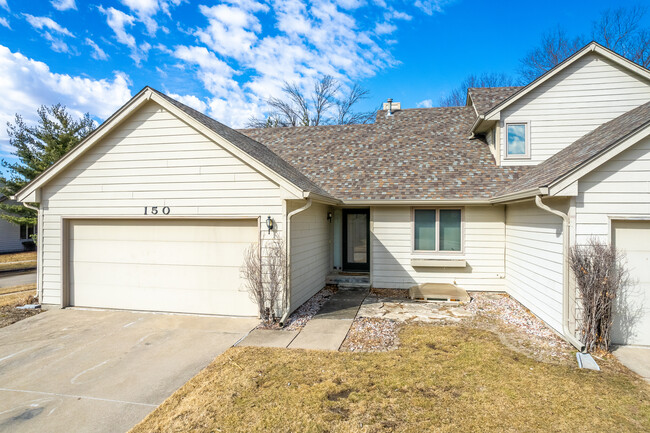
(413, 209, 463, 252)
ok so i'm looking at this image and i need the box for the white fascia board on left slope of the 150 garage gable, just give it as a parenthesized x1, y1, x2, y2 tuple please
(15, 88, 153, 203)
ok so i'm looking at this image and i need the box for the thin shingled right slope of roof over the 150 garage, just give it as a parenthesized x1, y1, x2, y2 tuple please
(151, 89, 329, 196)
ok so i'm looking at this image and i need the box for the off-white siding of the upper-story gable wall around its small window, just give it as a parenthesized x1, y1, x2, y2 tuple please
(500, 54, 650, 165)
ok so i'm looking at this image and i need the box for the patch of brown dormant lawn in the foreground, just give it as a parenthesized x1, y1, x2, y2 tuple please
(132, 325, 650, 433)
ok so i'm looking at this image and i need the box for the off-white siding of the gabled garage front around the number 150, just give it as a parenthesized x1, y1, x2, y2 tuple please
(41, 102, 284, 304)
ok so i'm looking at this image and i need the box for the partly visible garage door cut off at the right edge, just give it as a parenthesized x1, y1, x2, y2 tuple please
(612, 221, 650, 346)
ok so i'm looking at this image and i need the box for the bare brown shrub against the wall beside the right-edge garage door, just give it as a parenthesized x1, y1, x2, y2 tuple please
(569, 238, 629, 352)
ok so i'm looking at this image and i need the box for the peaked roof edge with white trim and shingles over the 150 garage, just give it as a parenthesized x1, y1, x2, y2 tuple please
(16, 87, 331, 202)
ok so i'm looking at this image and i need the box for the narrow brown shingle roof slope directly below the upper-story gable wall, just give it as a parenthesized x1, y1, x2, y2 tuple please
(498, 102, 650, 196)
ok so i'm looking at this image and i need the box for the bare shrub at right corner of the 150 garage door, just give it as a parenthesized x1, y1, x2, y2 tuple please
(241, 240, 287, 324)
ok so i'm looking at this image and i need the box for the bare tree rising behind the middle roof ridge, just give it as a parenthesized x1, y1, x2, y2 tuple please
(247, 75, 375, 128)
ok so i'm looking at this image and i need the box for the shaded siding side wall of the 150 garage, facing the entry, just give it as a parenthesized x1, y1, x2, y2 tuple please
(291, 202, 331, 311)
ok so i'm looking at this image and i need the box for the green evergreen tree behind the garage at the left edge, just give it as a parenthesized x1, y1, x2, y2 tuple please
(0, 104, 95, 225)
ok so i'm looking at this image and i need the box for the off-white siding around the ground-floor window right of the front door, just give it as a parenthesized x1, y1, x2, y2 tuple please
(370, 206, 504, 291)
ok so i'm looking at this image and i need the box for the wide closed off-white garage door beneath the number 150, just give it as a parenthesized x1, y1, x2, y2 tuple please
(68, 220, 259, 316)
